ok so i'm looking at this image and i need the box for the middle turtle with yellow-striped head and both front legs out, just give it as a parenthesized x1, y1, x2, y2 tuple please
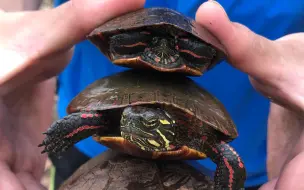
(39, 69, 246, 190)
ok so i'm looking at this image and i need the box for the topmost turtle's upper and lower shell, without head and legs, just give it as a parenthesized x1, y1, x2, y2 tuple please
(87, 7, 226, 76)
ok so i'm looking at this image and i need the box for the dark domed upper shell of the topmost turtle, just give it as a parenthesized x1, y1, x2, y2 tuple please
(88, 7, 225, 63)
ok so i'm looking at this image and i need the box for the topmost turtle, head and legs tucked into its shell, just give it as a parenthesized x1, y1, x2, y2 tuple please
(87, 7, 226, 76)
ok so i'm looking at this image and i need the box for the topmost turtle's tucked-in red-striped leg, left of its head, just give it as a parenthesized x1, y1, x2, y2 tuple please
(110, 32, 151, 54)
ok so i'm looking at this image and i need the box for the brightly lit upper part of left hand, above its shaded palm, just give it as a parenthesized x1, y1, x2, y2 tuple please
(0, 0, 144, 95)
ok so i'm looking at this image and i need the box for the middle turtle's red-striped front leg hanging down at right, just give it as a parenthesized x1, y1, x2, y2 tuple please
(204, 141, 246, 190)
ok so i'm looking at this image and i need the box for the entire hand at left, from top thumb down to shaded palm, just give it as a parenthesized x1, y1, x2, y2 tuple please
(0, 0, 144, 190)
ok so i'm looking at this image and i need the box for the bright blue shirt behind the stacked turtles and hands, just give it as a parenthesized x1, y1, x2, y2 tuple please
(55, 0, 304, 186)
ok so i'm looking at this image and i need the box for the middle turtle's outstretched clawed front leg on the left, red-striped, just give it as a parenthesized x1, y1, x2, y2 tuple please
(38, 111, 107, 156)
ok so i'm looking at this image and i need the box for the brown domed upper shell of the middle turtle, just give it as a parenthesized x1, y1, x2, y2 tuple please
(67, 70, 238, 138)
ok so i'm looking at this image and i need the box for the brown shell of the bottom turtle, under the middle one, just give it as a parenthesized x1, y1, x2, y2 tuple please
(59, 149, 214, 190)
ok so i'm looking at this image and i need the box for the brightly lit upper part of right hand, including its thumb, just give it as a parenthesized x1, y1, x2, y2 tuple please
(196, 0, 304, 115)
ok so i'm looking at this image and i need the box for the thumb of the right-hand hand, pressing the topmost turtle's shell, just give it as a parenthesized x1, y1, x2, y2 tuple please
(196, 0, 277, 79)
